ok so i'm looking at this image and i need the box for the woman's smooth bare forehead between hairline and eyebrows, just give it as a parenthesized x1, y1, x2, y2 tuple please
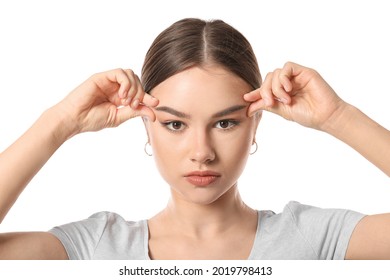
(150, 66, 251, 109)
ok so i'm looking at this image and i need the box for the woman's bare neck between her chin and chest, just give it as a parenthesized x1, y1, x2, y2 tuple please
(161, 185, 257, 238)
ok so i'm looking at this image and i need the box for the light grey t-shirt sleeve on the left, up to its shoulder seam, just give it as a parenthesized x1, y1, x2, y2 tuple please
(49, 212, 111, 260)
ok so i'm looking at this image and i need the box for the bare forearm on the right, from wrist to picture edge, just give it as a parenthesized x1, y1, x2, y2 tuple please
(324, 104, 390, 176)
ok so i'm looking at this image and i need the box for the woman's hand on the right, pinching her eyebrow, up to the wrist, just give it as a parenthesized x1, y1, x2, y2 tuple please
(244, 62, 346, 130)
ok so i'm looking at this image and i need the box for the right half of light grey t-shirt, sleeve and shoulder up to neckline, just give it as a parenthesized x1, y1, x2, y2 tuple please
(253, 201, 364, 259)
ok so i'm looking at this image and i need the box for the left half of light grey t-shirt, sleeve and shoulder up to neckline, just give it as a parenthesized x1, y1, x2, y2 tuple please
(50, 211, 147, 259)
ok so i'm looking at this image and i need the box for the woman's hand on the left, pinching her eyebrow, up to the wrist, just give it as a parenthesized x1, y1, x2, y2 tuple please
(56, 69, 158, 138)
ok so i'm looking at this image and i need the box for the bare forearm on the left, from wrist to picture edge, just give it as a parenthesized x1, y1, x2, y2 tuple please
(0, 104, 70, 222)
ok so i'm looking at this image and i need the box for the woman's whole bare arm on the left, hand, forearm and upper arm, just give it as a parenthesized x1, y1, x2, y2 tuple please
(0, 69, 158, 259)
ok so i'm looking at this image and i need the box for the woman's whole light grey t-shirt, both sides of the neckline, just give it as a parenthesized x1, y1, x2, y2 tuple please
(50, 202, 364, 260)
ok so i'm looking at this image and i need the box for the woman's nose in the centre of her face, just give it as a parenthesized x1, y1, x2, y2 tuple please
(190, 130, 215, 164)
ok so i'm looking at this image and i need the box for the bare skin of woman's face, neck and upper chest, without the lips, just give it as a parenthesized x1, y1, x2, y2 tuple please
(145, 66, 260, 259)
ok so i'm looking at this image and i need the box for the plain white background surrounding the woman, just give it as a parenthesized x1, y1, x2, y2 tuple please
(0, 0, 390, 232)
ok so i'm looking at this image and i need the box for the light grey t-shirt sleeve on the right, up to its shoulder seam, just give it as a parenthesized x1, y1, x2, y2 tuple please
(283, 202, 365, 260)
